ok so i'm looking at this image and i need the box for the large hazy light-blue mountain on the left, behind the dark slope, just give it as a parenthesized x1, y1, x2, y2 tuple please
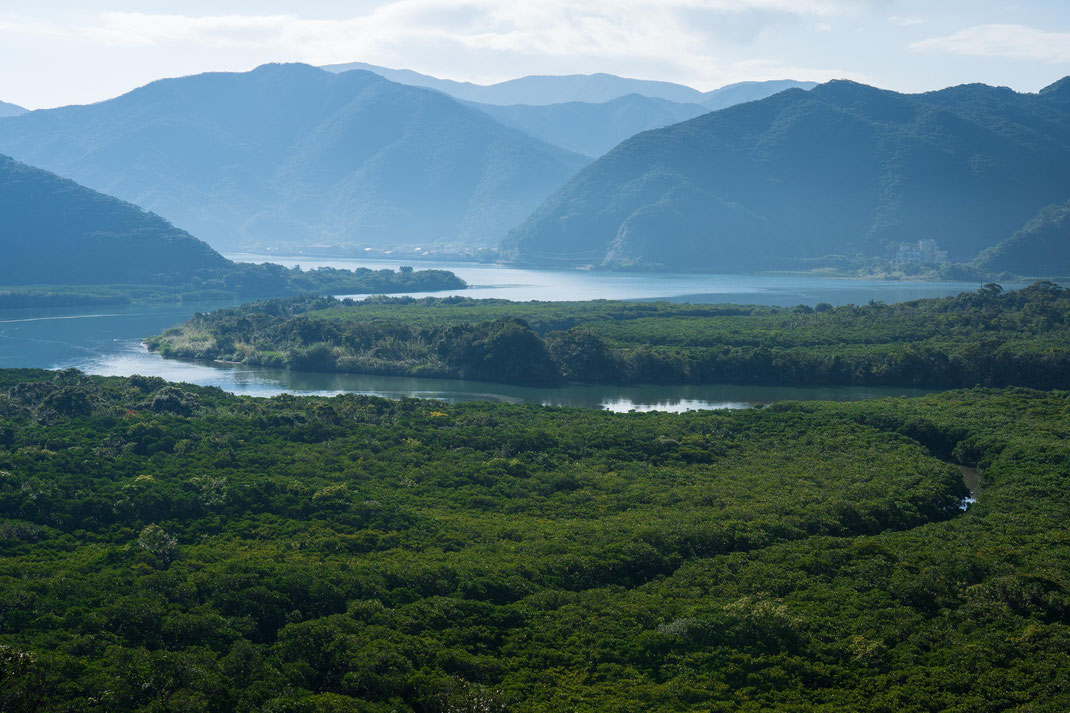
(0, 64, 586, 247)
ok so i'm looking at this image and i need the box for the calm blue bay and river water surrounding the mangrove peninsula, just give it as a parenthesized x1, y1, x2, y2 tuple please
(0, 256, 1012, 404)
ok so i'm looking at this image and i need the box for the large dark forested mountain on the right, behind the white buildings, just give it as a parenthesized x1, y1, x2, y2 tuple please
(504, 74, 1070, 270)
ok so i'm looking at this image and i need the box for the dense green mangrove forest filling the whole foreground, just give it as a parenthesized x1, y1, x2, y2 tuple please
(0, 370, 1070, 713)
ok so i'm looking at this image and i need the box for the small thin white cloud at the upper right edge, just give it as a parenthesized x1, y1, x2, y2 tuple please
(910, 25, 1070, 64)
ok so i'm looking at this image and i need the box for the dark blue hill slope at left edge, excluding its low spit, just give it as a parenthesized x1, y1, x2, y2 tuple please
(0, 155, 229, 285)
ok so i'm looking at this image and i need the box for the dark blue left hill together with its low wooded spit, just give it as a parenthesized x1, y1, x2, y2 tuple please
(0, 156, 464, 306)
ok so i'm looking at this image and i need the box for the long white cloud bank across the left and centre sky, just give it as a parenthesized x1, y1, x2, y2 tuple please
(0, 0, 872, 93)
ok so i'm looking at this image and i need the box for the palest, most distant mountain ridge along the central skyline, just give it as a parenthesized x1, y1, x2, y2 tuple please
(323, 62, 816, 110)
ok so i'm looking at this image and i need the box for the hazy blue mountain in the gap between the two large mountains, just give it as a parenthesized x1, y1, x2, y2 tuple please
(462, 94, 707, 157)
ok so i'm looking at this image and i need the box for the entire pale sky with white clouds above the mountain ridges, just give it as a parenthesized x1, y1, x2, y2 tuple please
(0, 0, 1070, 108)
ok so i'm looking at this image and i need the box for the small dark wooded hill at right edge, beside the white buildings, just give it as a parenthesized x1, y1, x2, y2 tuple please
(977, 200, 1070, 275)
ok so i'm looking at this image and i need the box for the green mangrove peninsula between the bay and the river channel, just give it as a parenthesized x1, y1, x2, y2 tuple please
(148, 283, 1070, 389)
